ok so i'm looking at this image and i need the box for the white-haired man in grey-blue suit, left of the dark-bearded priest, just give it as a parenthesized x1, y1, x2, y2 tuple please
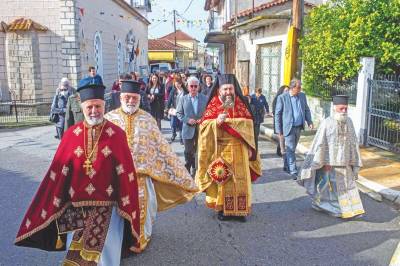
(176, 76, 207, 176)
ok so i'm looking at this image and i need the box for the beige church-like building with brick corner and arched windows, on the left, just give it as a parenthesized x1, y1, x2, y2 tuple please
(0, 0, 150, 99)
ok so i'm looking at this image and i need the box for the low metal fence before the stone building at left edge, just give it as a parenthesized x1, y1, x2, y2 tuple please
(0, 98, 53, 128)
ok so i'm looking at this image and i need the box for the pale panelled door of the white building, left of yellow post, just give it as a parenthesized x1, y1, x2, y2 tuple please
(256, 42, 282, 104)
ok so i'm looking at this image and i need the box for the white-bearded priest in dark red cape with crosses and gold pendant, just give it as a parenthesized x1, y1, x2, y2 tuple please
(15, 85, 140, 265)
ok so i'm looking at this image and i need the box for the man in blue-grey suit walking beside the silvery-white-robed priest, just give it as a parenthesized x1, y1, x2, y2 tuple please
(274, 79, 313, 179)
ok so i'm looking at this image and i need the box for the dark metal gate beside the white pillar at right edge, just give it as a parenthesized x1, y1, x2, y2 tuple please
(367, 78, 400, 153)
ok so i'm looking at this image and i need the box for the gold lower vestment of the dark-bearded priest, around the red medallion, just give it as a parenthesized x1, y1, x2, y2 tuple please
(196, 118, 261, 216)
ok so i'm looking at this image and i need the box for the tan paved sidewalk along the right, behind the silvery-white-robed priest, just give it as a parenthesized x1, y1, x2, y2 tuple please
(260, 117, 400, 206)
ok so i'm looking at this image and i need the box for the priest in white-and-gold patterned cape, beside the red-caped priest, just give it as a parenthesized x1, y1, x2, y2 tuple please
(105, 80, 198, 253)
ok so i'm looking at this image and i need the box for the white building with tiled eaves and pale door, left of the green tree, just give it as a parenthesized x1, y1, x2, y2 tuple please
(205, 0, 323, 102)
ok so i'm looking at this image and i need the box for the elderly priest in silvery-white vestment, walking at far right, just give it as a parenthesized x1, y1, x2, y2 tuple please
(299, 95, 364, 218)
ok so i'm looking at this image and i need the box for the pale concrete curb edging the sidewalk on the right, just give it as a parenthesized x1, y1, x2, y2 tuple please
(260, 125, 400, 206)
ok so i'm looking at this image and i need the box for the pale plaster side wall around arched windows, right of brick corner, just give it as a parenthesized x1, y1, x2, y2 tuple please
(77, 0, 148, 89)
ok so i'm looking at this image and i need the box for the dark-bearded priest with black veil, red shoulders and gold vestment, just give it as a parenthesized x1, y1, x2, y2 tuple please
(196, 74, 261, 221)
